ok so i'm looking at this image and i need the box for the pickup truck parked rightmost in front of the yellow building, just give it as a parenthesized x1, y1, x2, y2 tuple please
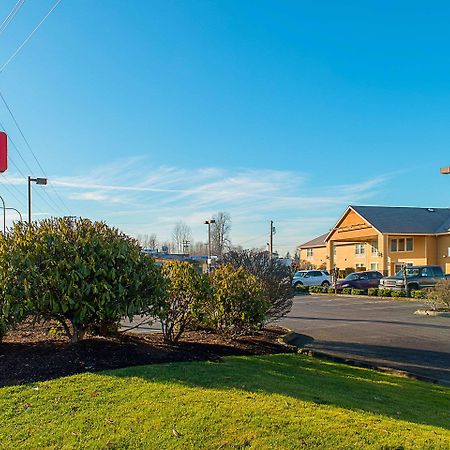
(380, 266, 448, 296)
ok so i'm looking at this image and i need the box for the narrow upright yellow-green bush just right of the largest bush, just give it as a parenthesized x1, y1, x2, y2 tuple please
(157, 261, 211, 342)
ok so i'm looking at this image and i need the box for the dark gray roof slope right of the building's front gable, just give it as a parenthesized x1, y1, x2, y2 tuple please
(350, 206, 450, 234)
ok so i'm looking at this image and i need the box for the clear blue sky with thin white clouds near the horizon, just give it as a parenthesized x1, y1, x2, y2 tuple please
(0, 0, 450, 253)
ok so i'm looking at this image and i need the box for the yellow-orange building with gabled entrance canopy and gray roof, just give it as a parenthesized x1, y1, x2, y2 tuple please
(298, 206, 450, 275)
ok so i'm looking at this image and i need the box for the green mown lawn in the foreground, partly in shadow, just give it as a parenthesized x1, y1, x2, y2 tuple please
(0, 354, 450, 450)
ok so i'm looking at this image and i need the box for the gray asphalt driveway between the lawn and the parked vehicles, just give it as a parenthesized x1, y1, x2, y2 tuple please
(281, 295, 450, 385)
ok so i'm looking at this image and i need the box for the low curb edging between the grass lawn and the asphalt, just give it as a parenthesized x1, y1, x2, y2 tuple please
(279, 328, 450, 386)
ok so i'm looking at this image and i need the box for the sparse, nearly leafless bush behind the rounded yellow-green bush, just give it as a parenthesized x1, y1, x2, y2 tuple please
(222, 250, 294, 322)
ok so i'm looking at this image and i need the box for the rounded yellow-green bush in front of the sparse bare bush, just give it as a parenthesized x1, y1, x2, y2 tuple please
(205, 264, 272, 334)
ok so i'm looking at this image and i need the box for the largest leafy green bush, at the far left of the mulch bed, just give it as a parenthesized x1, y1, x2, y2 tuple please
(0, 218, 162, 342)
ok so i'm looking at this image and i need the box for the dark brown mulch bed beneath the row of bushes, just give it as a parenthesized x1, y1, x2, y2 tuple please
(0, 322, 295, 386)
